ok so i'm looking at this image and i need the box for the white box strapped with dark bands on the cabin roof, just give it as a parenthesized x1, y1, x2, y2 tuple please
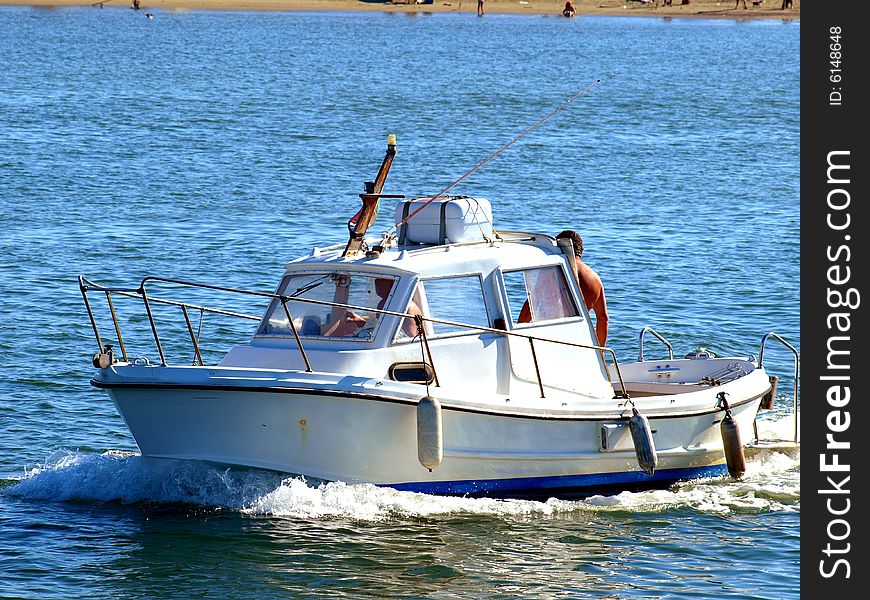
(396, 196, 492, 246)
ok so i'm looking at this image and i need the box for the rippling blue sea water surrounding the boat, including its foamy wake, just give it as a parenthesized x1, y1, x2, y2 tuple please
(0, 7, 800, 598)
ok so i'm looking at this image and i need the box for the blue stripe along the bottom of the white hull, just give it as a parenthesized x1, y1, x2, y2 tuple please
(385, 464, 728, 496)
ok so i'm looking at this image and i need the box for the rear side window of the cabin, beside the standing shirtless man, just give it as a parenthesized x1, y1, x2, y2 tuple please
(502, 266, 579, 325)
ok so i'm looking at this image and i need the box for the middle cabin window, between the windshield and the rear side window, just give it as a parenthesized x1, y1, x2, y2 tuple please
(419, 275, 489, 335)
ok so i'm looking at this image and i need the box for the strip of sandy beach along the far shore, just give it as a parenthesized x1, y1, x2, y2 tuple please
(0, 0, 801, 19)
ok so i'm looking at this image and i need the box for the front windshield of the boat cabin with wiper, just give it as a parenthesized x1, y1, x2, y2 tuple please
(257, 271, 396, 341)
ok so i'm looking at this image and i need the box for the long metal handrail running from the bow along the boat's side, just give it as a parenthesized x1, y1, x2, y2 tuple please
(78, 275, 632, 398)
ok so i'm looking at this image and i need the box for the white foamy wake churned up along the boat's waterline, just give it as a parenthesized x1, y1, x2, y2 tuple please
(0, 418, 800, 521)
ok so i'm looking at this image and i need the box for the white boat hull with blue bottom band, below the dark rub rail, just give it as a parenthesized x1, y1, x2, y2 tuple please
(95, 381, 761, 497)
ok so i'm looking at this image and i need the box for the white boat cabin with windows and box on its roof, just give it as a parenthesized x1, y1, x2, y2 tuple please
(220, 197, 613, 398)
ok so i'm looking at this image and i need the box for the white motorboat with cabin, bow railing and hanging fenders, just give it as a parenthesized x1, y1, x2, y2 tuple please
(79, 139, 797, 497)
